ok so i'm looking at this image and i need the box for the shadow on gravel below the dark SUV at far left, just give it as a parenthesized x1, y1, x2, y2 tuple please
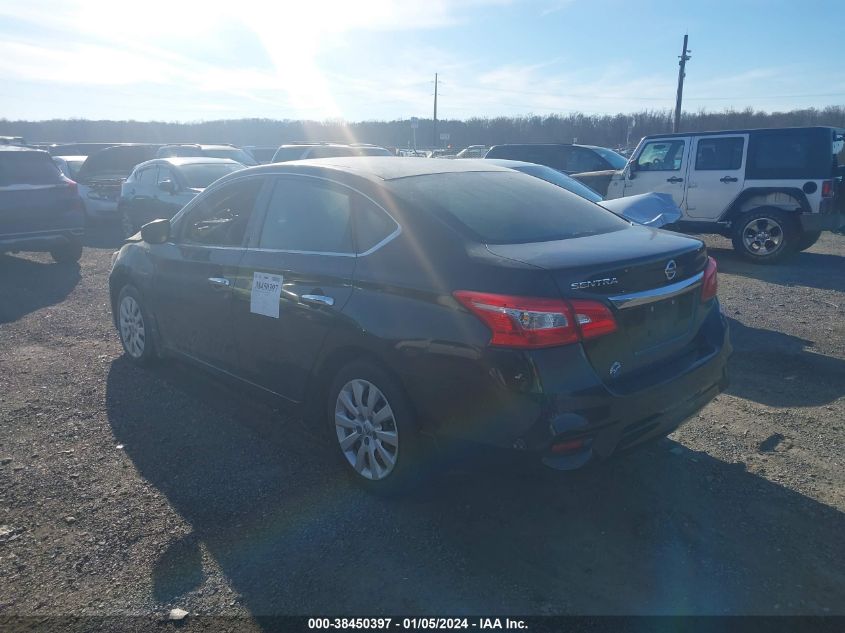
(0, 255, 81, 323)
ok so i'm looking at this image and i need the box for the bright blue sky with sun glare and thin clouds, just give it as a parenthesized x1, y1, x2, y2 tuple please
(0, 0, 845, 121)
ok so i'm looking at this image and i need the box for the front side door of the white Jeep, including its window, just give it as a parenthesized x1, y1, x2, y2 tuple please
(624, 136, 690, 208)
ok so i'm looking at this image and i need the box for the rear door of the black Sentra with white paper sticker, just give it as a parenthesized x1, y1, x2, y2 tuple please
(234, 175, 360, 402)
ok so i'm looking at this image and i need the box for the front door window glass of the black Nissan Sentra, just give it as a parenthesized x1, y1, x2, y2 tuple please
(181, 178, 264, 246)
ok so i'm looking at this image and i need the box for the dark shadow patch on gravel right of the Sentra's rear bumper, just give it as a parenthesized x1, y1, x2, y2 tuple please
(727, 318, 845, 407)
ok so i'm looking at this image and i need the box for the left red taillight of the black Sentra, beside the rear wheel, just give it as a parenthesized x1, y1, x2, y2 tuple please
(454, 290, 616, 349)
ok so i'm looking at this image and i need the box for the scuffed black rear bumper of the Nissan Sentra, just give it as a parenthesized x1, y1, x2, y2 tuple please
(416, 310, 732, 470)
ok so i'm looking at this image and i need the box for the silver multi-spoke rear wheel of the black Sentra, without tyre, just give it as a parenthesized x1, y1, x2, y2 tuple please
(334, 378, 399, 481)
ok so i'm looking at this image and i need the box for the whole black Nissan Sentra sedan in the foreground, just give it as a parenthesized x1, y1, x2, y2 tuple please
(109, 158, 731, 489)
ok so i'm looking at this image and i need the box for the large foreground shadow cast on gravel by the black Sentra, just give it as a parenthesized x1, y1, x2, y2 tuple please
(107, 358, 845, 616)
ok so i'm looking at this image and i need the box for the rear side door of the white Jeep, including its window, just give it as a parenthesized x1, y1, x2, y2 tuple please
(686, 134, 748, 220)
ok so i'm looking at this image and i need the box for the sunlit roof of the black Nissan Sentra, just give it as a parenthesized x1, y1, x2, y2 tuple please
(246, 156, 507, 180)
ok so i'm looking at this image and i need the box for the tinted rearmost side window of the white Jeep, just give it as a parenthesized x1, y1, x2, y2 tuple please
(745, 128, 833, 179)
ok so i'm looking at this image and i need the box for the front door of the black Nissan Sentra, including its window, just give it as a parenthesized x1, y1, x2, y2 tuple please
(150, 176, 266, 373)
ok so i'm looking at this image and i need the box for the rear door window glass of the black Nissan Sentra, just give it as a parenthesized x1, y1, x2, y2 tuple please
(258, 177, 352, 253)
